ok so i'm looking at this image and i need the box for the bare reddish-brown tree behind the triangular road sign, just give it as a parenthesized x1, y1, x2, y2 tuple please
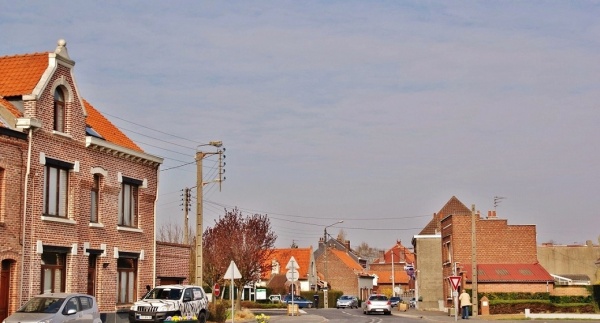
(202, 208, 277, 309)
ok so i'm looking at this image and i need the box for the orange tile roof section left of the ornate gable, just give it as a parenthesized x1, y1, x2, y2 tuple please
(0, 53, 48, 97)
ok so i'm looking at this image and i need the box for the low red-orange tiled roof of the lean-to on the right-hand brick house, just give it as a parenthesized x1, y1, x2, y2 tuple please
(463, 263, 554, 282)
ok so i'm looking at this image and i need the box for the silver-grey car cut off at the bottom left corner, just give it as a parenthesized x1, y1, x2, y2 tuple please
(2, 293, 102, 323)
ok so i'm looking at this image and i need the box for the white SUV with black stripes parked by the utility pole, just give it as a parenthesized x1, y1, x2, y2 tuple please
(129, 285, 208, 323)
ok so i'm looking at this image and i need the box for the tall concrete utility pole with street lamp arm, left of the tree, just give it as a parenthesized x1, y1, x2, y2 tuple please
(195, 141, 225, 286)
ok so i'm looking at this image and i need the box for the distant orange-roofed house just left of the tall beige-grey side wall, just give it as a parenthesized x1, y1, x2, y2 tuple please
(369, 241, 415, 297)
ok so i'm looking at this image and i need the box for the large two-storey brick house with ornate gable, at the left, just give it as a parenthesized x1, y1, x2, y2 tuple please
(0, 40, 162, 319)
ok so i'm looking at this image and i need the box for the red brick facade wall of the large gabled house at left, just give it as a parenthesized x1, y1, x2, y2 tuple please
(0, 52, 158, 312)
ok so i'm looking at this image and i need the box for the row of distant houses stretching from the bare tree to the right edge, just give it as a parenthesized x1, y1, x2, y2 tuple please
(262, 196, 600, 310)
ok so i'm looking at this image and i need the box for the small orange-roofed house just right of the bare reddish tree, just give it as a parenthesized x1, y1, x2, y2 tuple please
(257, 247, 317, 295)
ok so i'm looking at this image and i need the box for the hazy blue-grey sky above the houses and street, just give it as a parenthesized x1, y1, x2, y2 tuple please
(0, 0, 600, 249)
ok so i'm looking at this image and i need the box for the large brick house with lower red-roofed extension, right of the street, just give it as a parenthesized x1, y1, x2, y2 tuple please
(416, 196, 554, 312)
